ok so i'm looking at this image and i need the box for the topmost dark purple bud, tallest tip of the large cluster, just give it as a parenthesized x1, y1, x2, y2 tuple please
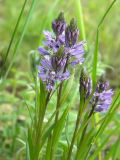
(52, 12, 66, 36)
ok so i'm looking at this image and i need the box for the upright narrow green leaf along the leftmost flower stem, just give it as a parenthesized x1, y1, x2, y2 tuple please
(33, 80, 46, 159)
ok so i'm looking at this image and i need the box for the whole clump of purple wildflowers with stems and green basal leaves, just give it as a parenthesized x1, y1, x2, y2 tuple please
(24, 3, 118, 160)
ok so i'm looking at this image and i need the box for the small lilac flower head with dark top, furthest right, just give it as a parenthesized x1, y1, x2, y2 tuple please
(92, 82, 114, 112)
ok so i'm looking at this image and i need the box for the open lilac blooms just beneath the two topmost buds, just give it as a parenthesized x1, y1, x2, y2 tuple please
(38, 31, 85, 65)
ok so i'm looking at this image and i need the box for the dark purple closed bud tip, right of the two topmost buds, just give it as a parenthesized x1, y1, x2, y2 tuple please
(65, 19, 79, 47)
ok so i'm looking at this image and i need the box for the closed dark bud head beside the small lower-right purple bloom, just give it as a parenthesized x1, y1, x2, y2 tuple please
(79, 70, 92, 100)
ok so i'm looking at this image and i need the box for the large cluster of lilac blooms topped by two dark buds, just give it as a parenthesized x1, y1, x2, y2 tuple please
(38, 13, 84, 91)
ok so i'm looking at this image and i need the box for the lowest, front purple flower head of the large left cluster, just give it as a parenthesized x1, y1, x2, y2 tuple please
(38, 56, 70, 90)
